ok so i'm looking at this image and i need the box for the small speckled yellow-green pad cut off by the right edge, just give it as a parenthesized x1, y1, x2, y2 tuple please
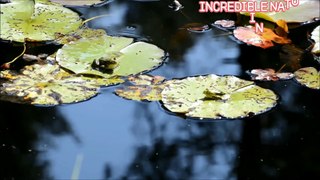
(294, 67, 320, 89)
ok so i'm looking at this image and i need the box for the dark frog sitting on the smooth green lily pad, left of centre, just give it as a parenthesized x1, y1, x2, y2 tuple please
(91, 52, 122, 74)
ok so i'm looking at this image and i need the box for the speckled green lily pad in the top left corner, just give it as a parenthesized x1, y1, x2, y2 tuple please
(0, 0, 82, 42)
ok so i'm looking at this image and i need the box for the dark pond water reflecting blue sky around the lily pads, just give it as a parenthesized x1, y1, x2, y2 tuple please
(0, 0, 320, 179)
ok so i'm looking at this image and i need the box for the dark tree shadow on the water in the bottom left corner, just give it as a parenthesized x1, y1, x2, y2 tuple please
(0, 101, 76, 179)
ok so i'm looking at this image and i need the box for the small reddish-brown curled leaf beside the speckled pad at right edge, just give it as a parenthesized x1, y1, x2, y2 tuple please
(249, 69, 294, 81)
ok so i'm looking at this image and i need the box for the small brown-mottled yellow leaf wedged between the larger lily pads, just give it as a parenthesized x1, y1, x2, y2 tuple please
(115, 75, 167, 101)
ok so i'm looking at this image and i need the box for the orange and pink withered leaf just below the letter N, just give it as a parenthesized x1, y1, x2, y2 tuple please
(233, 26, 291, 49)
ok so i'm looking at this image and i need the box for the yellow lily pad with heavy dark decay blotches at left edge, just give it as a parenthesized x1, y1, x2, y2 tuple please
(0, 64, 99, 105)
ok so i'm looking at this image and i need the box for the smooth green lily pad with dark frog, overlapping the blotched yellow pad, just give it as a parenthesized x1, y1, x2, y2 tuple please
(56, 35, 164, 77)
